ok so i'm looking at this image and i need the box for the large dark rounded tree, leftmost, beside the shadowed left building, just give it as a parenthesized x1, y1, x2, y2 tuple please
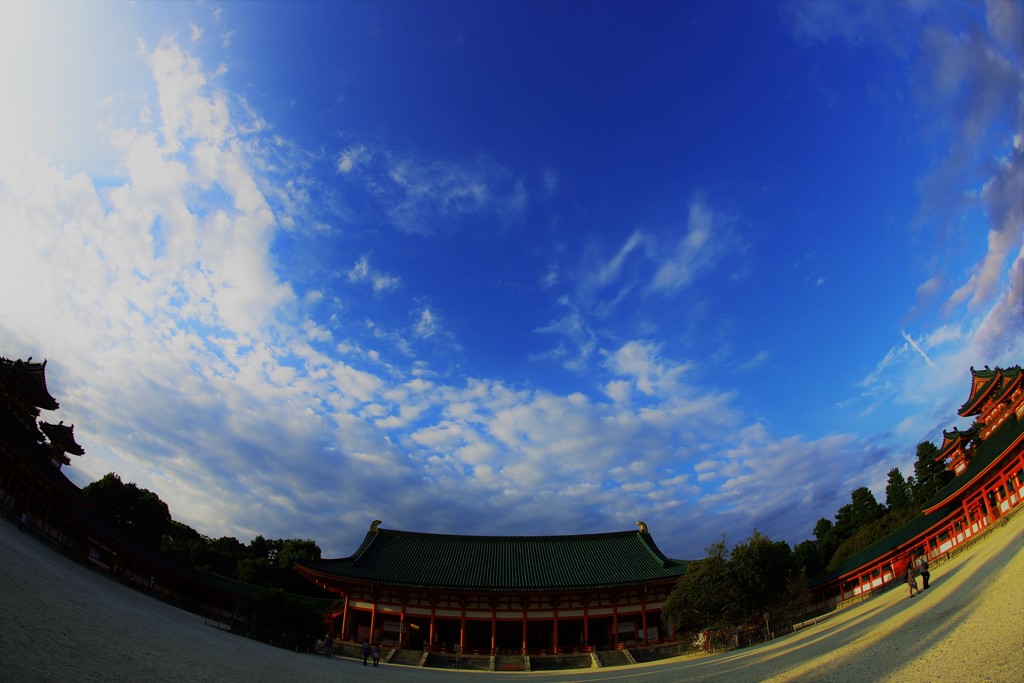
(82, 472, 171, 546)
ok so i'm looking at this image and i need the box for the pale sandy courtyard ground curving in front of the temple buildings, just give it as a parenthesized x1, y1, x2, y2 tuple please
(0, 513, 1024, 683)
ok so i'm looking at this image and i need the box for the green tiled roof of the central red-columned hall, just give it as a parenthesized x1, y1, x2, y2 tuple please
(301, 528, 688, 592)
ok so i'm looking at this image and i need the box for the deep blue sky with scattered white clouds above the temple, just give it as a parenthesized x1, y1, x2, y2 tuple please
(0, 1, 1024, 558)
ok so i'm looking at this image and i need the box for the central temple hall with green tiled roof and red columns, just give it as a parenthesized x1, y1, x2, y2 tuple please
(296, 521, 688, 654)
